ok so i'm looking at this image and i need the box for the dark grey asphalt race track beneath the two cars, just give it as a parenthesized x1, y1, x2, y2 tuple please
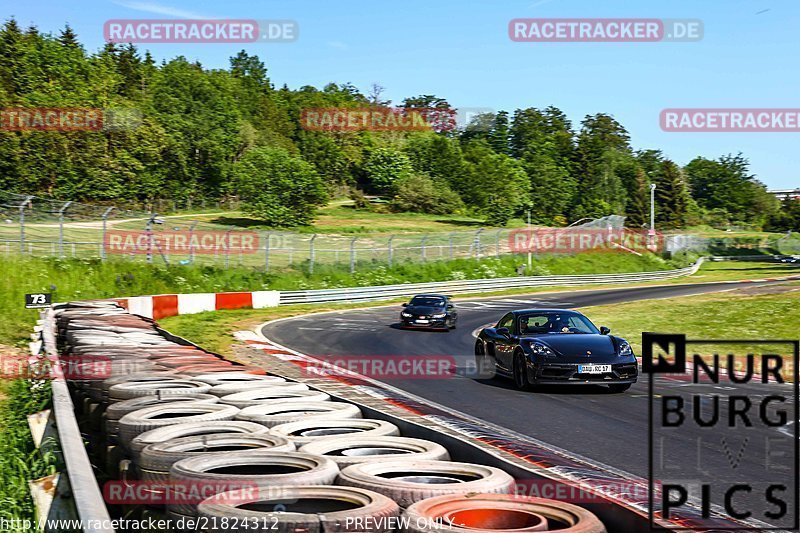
(263, 282, 793, 520)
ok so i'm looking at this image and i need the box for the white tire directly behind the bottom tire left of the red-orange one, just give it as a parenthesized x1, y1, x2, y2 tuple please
(167, 450, 339, 516)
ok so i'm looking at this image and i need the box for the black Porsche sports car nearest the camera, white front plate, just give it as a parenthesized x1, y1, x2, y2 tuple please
(475, 309, 639, 392)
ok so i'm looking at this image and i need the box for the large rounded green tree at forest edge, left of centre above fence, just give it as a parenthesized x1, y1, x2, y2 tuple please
(233, 148, 328, 226)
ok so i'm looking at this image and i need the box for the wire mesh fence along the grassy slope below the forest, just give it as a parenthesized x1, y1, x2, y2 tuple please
(0, 191, 672, 272)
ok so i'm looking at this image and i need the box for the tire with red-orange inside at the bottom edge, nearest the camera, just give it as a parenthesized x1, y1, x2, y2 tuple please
(403, 494, 606, 533)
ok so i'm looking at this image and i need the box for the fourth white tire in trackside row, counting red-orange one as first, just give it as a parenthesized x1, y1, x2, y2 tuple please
(270, 418, 400, 446)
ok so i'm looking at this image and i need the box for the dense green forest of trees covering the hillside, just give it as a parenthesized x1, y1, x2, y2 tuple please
(0, 19, 798, 229)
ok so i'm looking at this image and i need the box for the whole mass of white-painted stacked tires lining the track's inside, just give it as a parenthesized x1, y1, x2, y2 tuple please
(56, 302, 605, 533)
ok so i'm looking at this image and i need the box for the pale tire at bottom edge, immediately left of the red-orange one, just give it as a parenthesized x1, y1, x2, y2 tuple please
(197, 486, 400, 533)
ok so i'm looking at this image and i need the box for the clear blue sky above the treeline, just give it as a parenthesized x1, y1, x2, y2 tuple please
(7, 0, 800, 188)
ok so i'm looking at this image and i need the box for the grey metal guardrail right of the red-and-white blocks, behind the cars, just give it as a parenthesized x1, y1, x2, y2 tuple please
(279, 257, 705, 305)
